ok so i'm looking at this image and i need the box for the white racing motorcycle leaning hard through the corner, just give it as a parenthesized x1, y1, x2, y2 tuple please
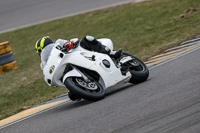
(43, 39, 149, 101)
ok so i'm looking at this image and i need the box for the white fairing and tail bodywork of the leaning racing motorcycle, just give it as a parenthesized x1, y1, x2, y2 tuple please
(43, 39, 131, 89)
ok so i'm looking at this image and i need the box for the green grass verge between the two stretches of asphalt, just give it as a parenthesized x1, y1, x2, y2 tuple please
(0, 0, 200, 119)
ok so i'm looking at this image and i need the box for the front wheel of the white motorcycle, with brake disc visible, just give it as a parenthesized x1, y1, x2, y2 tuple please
(64, 77, 105, 101)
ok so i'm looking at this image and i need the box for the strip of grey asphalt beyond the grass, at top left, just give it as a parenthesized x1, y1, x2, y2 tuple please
(0, 0, 136, 33)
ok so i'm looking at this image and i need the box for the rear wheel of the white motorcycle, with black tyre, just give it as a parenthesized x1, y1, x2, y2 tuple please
(123, 53, 149, 84)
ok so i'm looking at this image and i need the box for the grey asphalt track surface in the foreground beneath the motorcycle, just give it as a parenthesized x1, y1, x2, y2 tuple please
(0, 46, 200, 133)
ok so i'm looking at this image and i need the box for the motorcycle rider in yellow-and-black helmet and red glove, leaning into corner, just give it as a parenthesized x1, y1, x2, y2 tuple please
(35, 35, 122, 101)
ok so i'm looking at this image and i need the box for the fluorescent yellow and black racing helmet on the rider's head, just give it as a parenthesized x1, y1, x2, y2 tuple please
(35, 36, 53, 55)
